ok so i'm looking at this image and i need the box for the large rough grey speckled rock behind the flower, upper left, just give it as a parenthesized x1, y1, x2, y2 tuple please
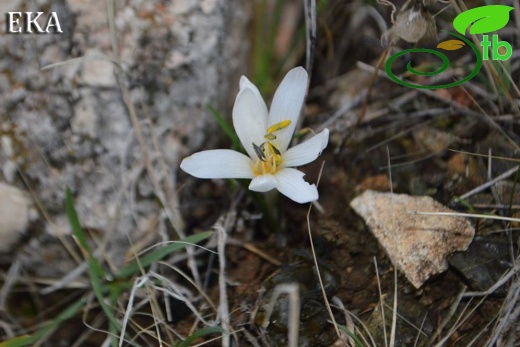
(0, 0, 251, 263)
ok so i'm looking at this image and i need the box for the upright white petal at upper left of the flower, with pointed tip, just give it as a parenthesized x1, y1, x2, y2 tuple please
(233, 87, 267, 158)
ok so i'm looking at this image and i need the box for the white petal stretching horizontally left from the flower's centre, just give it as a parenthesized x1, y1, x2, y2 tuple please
(181, 149, 254, 178)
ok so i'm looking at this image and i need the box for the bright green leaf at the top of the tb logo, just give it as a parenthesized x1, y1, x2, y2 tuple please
(453, 5, 514, 35)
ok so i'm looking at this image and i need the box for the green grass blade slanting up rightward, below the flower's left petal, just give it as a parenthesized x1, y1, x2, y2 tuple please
(116, 231, 213, 278)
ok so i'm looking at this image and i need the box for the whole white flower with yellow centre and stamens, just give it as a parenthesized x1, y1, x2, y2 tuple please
(181, 67, 329, 203)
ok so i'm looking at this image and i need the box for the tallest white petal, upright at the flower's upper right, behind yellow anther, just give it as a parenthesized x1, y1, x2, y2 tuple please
(267, 67, 308, 153)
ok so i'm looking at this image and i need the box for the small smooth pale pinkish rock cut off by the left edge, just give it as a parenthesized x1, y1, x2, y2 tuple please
(0, 182, 31, 253)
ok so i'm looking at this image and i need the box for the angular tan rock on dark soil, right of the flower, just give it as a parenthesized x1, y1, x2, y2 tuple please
(350, 190, 475, 288)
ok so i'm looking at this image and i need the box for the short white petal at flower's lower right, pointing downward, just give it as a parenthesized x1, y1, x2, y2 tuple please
(275, 168, 319, 204)
